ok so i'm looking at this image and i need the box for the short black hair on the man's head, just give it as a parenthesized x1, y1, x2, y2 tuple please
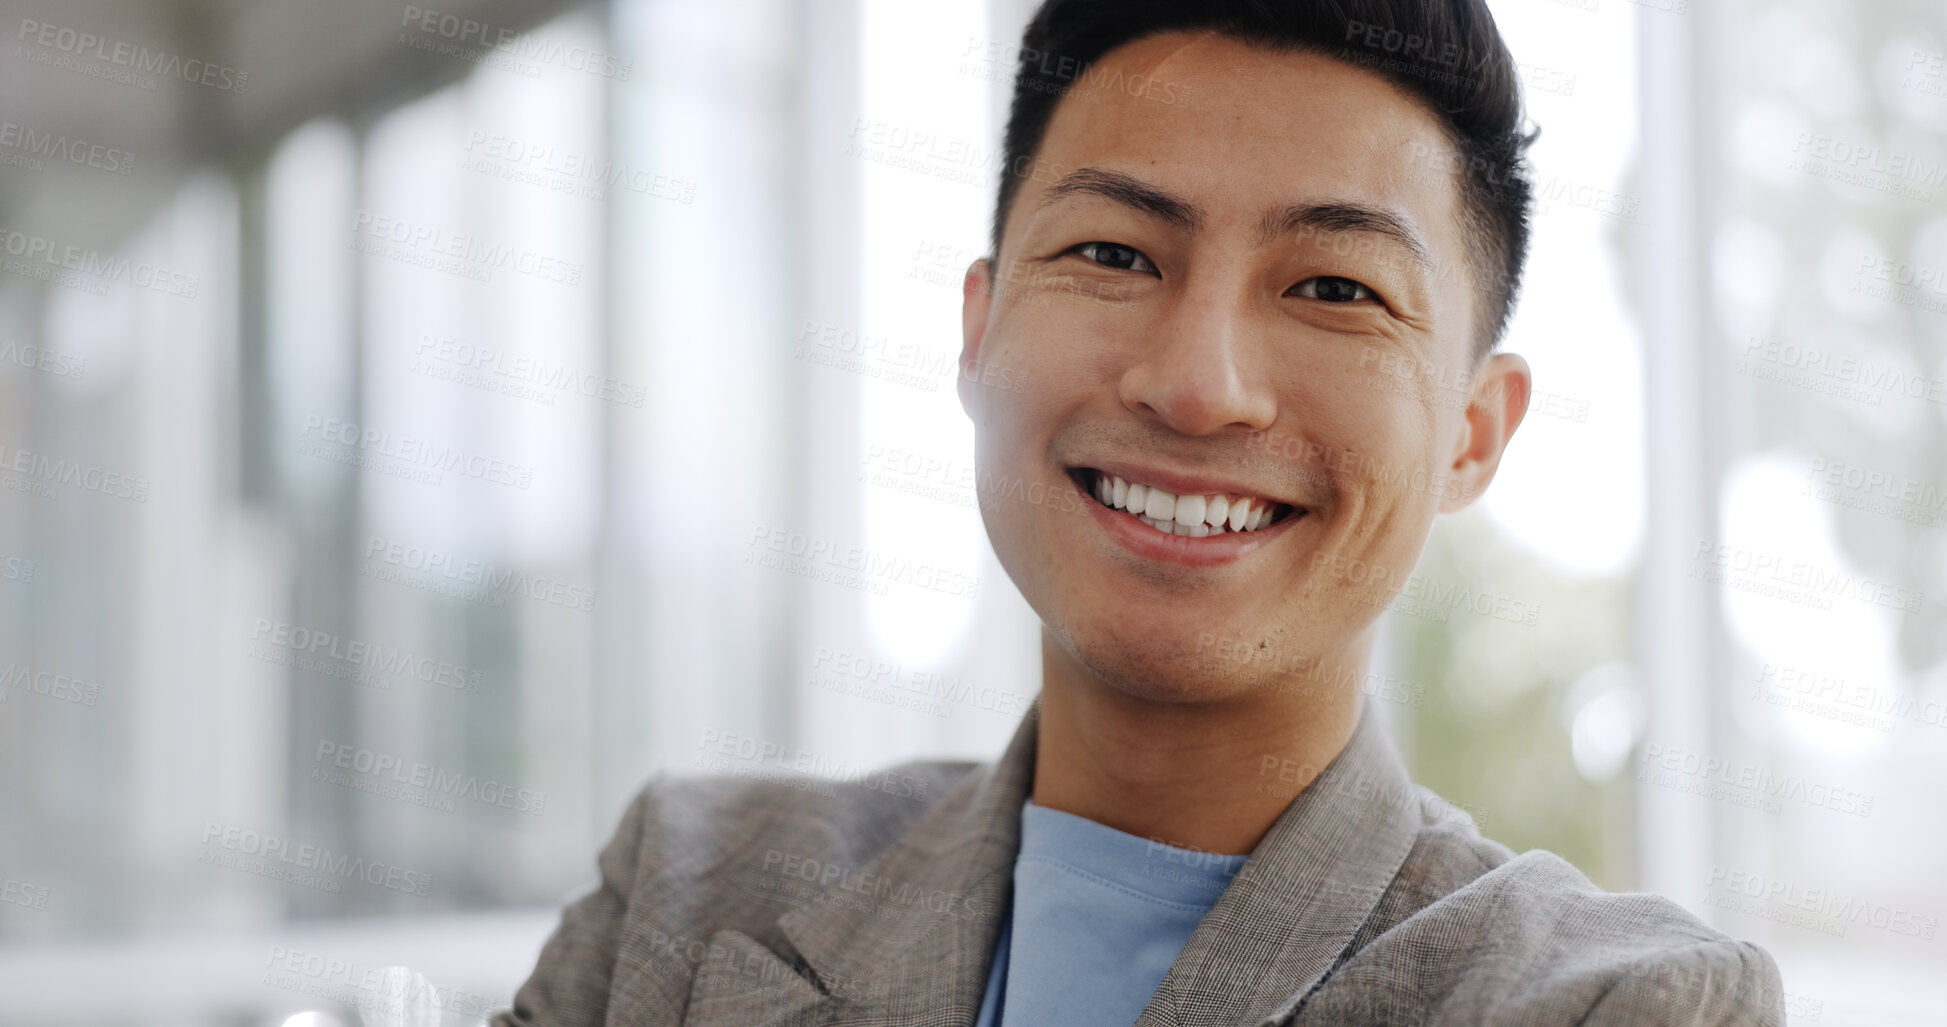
(991, 0, 1536, 357)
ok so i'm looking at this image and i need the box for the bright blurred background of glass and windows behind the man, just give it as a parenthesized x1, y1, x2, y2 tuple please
(0, 0, 1947, 1025)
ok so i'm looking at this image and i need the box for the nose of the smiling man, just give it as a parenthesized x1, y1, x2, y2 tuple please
(1118, 284, 1277, 435)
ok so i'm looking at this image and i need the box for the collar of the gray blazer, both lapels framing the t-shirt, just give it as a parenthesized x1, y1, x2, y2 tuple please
(777, 698, 1419, 1027)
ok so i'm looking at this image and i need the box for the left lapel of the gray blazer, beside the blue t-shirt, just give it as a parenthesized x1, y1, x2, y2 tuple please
(685, 700, 1040, 1027)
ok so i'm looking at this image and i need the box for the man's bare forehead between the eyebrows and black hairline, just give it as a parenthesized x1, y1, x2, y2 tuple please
(1010, 33, 1458, 249)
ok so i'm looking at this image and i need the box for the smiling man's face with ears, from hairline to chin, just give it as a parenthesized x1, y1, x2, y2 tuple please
(960, 33, 1526, 702)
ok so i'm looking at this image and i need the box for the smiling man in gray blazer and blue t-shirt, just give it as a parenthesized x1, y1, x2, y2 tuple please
(498, 0, 1782, 1027)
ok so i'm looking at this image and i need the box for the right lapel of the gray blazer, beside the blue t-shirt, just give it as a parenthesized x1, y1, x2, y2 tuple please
(1137, 709, 1419, 1027)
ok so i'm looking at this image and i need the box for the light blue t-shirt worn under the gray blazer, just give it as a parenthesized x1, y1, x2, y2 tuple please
(975, 801, 1248, 1027)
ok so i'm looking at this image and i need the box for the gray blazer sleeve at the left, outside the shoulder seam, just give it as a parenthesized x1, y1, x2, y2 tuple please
(493, 789, 648, 1027)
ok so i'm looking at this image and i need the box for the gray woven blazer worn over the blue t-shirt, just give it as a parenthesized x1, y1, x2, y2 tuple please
(493, 704, 1783, 1027)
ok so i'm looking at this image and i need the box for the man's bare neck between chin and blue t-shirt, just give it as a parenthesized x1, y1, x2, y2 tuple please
(1034, 631, 1371, 856)
